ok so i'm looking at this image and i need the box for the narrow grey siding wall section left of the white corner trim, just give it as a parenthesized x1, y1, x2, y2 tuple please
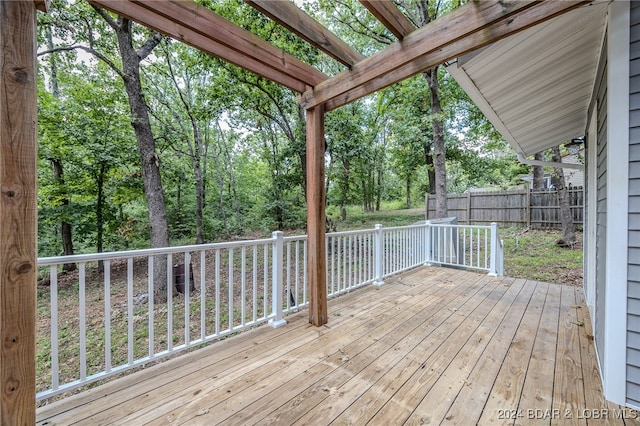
(591, 33, 607, 371)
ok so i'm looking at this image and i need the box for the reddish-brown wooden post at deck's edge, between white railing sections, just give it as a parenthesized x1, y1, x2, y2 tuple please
(307, 105, 327, 326)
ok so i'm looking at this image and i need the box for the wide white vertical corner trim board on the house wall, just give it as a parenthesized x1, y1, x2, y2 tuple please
(602, 1, 631, 405)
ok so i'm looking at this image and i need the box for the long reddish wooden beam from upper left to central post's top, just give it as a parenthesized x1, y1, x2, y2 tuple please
(90, 0, 328, 92)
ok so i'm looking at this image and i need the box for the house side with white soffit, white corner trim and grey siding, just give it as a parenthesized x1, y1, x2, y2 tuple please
(449, 1, 640, 409)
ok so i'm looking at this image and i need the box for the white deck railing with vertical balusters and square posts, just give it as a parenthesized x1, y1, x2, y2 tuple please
(37, 222, 502, 400)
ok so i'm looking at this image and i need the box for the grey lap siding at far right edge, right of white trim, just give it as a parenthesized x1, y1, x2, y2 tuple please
(627, 1, 640, 407)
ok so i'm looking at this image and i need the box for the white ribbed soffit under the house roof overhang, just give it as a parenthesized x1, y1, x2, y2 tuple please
(448, 2, 608, 155)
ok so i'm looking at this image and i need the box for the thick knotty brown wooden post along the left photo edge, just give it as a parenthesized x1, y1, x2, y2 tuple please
(0, 0, 37, 425)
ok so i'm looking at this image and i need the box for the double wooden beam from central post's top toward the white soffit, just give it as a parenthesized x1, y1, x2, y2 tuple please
(300, 0, 588, 111)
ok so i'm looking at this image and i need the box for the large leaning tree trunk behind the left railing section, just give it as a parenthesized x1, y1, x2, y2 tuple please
(116, 17, 175, 303)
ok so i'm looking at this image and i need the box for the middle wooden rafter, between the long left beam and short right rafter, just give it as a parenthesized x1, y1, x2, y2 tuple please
(245, 0, 365, 67)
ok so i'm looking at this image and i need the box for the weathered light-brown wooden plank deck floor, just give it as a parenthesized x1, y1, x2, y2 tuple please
(38, 267, 640, 425)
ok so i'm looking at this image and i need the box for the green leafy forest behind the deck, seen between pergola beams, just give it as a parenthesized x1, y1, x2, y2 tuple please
(38, 0, 530, 262)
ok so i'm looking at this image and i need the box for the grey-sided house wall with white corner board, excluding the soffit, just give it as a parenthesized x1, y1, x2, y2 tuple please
(585, 2, 640, 408)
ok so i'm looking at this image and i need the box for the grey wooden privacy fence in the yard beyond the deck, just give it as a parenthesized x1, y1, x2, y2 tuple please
(425, 186, 584, 229)
